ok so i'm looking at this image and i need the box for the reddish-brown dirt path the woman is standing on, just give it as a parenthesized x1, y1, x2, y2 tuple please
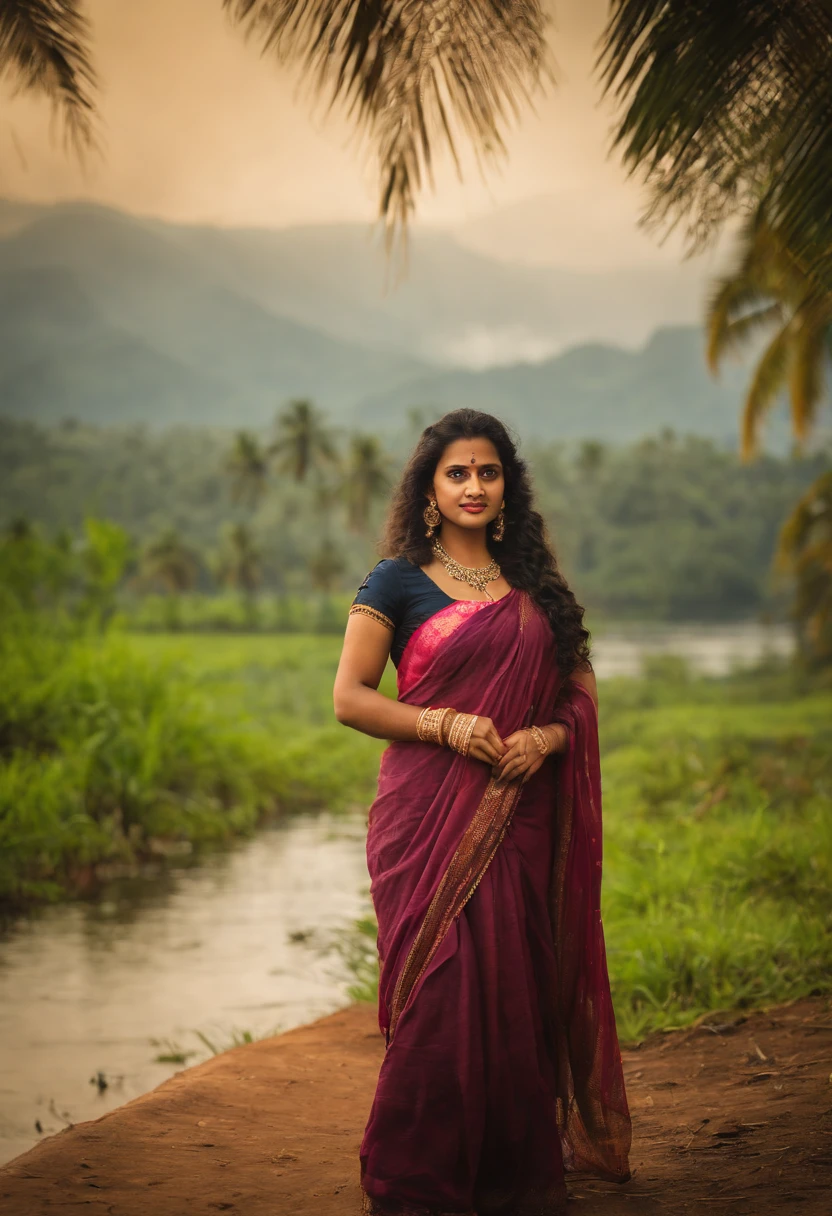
(0, 1000, 832, 1216)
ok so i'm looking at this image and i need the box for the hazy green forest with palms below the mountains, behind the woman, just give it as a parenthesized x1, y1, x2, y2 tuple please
(0, 415, 828, 629)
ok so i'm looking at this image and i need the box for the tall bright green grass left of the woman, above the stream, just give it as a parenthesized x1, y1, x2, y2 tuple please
(0, 630, 382, 905)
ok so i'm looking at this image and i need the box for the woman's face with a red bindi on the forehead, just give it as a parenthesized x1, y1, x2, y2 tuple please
(433, 437, 506, 528)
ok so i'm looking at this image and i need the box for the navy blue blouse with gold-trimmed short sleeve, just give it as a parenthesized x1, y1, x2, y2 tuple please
(350, 557, 455, 668)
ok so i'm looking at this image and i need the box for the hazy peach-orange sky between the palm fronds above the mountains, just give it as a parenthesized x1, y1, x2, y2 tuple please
(0, 0, 715, 266)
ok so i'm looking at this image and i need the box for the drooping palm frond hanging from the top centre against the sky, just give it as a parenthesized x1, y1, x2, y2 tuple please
(223, 0, 549, 241)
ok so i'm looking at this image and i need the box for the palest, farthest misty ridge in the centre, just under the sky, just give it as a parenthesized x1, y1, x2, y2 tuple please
(155, 216, 702, 367)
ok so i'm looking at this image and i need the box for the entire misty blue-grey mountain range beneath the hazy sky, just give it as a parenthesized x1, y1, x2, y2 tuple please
(0, 202, 759, 441)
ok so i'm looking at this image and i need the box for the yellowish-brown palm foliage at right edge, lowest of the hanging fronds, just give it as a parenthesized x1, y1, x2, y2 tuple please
(776, 471, 832, 664)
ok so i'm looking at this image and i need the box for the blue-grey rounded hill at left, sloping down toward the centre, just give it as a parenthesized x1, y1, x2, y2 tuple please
(0, 201, 425, 426)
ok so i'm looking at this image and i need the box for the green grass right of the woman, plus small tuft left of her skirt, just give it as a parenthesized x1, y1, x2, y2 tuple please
(344, 662, 832, 1040)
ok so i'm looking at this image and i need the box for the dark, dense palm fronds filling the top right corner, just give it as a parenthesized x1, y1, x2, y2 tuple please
(598, 0, 832, 291)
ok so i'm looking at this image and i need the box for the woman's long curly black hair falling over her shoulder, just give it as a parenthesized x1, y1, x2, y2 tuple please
(382, 410, 591, 677)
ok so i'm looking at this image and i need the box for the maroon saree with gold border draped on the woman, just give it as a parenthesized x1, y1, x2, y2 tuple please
(360, 590, 630, 1216)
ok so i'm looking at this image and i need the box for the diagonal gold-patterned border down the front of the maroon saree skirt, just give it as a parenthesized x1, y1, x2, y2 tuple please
(388, 777, 522, 1045)
